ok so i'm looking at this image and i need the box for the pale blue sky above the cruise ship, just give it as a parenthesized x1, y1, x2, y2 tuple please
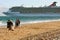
(0, 0, 60, 8)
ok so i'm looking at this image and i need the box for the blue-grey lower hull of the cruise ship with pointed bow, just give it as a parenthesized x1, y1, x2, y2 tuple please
(4, 12, 60, 16)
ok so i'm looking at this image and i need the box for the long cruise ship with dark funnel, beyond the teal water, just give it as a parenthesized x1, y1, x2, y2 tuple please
(3, 2, 60, 16)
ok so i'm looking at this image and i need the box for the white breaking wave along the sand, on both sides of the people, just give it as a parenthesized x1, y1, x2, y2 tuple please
(0, 19, 60, 26)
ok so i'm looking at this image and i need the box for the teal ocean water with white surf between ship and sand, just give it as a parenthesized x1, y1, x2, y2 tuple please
(0, 15, 60, 26)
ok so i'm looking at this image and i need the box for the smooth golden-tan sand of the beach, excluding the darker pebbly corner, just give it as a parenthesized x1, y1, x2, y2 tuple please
(0, 21, 60, 40)
